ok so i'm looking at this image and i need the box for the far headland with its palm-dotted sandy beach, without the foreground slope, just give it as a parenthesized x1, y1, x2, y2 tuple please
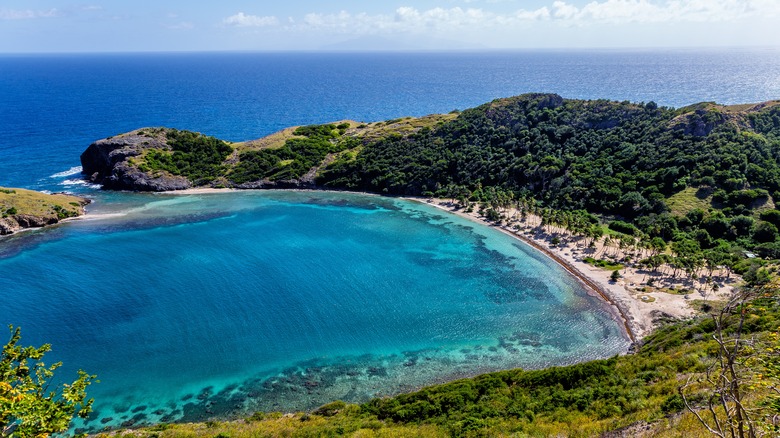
(81, 94, 780, 326)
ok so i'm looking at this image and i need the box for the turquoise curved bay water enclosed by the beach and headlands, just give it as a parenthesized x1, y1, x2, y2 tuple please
(0, 191, 629, 431)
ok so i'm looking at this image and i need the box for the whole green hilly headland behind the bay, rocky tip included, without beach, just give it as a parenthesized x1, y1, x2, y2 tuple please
(81, 94, 780, 250)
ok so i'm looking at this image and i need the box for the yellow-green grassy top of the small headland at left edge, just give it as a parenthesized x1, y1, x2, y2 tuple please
(0, 187, 83, 219)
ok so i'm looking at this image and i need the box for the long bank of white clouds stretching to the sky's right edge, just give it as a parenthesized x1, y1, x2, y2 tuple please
(278, 0, 780, 34)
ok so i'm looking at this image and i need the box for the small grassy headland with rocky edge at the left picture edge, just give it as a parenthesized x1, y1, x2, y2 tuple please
(0, 187, 90, 235)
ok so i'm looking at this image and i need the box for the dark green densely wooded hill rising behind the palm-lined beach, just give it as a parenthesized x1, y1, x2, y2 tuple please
(319, 94, 780, 218)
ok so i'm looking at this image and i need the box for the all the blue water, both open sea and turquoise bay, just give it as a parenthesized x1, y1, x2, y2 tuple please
(0, 49, 780, 430)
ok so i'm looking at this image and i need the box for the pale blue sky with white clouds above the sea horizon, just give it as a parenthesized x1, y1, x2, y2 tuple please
(0, 0, 780, 53)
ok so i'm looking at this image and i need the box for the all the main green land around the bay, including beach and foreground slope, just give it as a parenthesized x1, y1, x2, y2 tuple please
(74, 94, 780, 436)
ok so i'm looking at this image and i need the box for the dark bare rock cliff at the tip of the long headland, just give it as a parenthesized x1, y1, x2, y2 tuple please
(81, 130, 192, 192)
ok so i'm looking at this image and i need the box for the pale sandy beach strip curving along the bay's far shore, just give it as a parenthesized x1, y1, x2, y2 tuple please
(157, 187, 733, 344)
